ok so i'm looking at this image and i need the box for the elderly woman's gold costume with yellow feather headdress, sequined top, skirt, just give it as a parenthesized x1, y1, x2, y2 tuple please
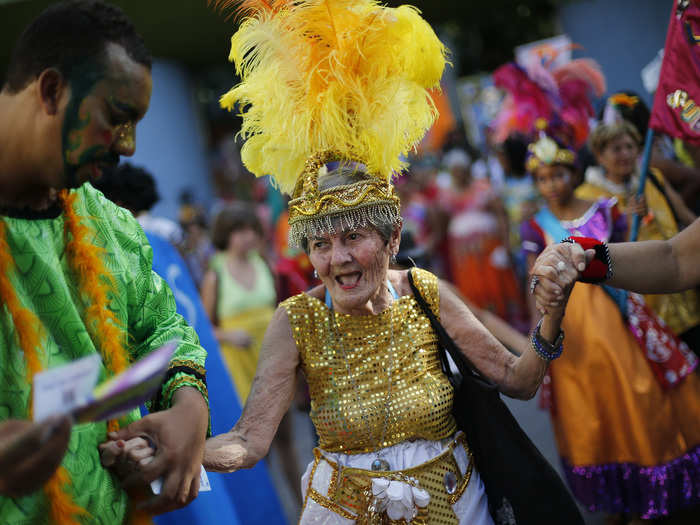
(216, 0, 492, 525)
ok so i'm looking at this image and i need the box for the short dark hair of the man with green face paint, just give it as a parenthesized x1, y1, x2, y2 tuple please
(3, 0, 151, 93)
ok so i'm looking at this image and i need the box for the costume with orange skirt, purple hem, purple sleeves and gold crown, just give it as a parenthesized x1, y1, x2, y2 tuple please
(521, 137, 700, 518)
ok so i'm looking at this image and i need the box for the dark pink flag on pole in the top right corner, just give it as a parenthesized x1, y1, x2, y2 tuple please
(649, 0, 700, 145)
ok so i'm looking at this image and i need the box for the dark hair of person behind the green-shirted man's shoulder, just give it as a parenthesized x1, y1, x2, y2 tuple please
(92, 162, 160, 214)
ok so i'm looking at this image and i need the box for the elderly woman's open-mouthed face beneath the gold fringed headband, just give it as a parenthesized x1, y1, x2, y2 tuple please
(309, 223, 401, 313)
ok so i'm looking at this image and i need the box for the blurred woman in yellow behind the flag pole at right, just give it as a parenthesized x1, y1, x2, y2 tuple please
(576, 121, 700, 353)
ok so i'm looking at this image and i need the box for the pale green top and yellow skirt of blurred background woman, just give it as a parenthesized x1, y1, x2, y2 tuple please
(211, 253, 277, 403)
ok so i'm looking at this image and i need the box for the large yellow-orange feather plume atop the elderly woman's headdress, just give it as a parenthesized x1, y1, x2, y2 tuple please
(219, 0, 446, 193)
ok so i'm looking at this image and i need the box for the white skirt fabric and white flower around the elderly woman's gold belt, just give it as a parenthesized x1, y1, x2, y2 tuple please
(299, 439, 493, 525)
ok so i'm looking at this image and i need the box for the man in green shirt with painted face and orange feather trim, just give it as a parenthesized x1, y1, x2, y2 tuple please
(0, 0, 208, 525)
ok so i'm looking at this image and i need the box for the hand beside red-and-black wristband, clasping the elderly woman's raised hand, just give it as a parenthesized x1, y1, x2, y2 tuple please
(530, 242, 595, 314)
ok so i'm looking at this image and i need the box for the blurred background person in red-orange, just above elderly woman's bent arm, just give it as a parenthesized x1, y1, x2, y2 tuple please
(443, 150, 528, 330)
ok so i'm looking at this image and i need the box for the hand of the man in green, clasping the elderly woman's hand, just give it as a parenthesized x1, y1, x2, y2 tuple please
(109, 387, 209, 514)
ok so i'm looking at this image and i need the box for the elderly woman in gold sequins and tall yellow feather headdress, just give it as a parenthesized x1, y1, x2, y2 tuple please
(205, 0, 576, 524)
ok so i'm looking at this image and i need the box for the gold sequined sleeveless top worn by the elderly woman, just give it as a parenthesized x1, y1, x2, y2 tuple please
(282, 270, 456, 454)
